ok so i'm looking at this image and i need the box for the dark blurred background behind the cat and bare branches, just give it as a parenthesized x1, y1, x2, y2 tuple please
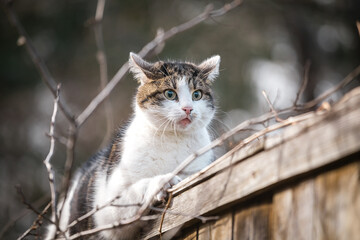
(0, 0, 360, 239)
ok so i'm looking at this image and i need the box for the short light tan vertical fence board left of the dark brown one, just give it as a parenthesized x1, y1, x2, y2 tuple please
(198, 213, 232, 240)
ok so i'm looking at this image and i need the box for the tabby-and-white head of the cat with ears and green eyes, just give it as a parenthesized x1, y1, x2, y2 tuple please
(129, 53, 220, 132)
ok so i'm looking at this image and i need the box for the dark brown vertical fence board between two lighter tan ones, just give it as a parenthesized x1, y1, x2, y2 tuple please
(233, 203, 272, 240)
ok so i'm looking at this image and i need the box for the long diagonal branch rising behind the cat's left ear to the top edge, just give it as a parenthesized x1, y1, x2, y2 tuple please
(76, 0, 242, 126)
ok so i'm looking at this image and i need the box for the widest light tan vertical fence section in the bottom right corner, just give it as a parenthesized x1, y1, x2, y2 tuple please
(273, 162, 360, 240)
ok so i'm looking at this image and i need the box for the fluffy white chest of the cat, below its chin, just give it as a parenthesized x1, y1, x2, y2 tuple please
(120, 116, 212, 178)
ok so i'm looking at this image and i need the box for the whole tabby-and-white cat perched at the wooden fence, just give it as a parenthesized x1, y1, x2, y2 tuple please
(46, 53, 220, 239)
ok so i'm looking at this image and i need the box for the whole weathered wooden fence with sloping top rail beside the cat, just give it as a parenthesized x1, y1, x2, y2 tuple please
(146, 88, 360, 240)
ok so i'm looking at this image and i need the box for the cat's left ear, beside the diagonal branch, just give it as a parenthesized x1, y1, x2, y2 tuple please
(129, 52, 154, 85)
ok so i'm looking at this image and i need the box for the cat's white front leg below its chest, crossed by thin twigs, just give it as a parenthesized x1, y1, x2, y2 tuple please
(94, 174, 181, 239)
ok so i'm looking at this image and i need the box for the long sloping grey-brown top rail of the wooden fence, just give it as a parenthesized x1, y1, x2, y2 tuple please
(148, 88, 360, 236)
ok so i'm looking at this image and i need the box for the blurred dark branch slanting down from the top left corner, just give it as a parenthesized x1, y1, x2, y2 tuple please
(1, 0, 75, 123)
